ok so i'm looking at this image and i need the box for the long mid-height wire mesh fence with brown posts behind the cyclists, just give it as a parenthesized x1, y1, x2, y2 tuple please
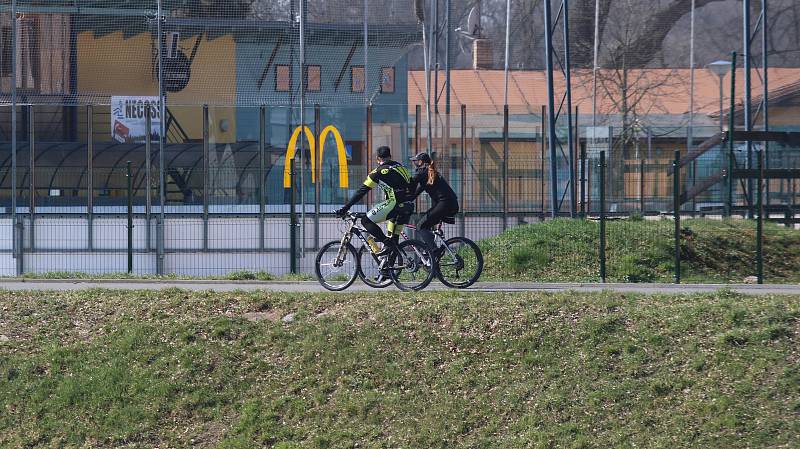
(0, 100, 797, 282)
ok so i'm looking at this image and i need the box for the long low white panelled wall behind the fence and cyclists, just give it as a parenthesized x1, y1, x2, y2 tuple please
(0, 213, 512, 276)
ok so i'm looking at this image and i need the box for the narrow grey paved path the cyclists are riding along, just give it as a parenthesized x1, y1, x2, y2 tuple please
(0, 279, 800, 295)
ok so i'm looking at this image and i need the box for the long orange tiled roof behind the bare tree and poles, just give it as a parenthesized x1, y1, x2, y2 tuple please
(408, 68, 800, 115)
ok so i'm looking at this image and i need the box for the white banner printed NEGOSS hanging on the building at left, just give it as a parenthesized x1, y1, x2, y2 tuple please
(111, 96, 161, 143)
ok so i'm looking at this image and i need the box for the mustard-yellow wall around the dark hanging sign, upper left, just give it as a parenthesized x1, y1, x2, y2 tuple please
(78, 32, 236, 143)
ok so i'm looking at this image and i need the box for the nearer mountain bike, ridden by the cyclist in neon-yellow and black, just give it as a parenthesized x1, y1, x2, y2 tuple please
(314, 212, 435, 291)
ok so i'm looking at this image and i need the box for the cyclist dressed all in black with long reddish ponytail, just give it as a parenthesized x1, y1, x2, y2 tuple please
(411, 153, 458, 255)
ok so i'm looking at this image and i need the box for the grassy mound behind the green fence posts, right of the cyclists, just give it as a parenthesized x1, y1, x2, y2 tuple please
(481, 219, 800, 282)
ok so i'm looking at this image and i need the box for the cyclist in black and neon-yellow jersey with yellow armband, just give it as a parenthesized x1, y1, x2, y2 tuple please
(335, 146, 414, 252)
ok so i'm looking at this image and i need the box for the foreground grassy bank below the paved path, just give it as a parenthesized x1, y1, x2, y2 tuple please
(0, 289, 800, 448)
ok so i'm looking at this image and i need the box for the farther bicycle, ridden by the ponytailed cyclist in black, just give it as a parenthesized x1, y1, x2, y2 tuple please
(358, 217, 483, 288)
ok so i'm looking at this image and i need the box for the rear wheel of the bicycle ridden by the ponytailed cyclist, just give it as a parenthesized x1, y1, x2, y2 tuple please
(436, 237, 483, 288)
